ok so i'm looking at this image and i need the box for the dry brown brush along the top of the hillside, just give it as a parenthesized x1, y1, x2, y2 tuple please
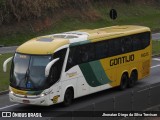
(0, 0, 160, 25)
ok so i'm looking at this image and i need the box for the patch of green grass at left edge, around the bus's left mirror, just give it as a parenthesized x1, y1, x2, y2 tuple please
(0, 53, 13, 91)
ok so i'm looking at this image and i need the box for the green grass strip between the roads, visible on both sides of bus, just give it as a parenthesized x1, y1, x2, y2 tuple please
(0, 40, 160, 91)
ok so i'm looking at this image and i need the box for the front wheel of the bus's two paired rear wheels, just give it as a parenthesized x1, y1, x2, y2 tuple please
(119, 73, 128, 90)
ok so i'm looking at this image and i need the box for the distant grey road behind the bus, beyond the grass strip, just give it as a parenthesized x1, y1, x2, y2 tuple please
(0, 33, 160, 54)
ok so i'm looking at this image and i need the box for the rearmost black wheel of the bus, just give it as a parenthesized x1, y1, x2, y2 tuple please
(128, 71, 138, 87)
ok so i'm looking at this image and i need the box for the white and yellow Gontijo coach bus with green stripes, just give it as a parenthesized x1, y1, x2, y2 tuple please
(4, 25, 151, 106)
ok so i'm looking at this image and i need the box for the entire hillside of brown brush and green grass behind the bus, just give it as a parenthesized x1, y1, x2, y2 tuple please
(0, 0, 160, 45)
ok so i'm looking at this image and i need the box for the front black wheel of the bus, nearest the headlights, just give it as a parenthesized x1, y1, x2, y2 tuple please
(63, 89, 74, 106)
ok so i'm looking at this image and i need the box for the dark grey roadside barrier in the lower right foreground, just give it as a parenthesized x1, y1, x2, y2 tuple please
(72, 83, 160, 111)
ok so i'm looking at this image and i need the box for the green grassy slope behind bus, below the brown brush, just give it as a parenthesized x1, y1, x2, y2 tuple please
(0, 3, 160, 46)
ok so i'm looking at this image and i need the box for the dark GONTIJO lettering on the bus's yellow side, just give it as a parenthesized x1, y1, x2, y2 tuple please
(110, 54, 134, 66)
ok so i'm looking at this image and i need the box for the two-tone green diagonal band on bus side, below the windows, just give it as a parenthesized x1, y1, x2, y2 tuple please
(80, 61, 111, 87)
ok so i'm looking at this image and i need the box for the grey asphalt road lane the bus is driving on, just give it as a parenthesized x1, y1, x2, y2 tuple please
(0, 57, 160, 120)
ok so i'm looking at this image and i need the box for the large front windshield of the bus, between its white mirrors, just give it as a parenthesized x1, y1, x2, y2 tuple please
(10, 53, 51, 90)
